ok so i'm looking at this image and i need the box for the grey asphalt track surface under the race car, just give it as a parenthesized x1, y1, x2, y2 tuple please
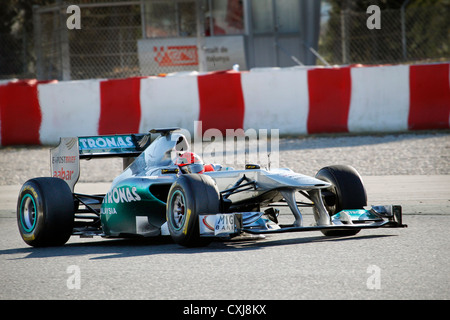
(0, 134, 450, 304)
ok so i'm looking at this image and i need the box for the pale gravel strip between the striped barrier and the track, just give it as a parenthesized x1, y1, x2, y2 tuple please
(0, 131, 450, 185)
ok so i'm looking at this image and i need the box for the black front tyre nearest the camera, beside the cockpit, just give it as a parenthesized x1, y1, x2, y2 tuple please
(166, 174, 220, 247)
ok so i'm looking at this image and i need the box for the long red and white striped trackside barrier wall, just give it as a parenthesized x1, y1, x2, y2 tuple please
(0, 63, 450, 145)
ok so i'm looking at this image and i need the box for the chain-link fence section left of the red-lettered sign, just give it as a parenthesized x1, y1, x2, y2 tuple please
(34, 1, 142, 80)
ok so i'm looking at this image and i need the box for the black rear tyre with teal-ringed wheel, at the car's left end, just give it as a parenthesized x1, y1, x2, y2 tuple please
(17, 177, 74, 247)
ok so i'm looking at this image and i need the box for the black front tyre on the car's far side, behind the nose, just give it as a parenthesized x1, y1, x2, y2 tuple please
(316, 165, 367, 236)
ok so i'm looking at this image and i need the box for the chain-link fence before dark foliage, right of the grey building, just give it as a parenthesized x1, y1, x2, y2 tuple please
(319, 5, 450, 64)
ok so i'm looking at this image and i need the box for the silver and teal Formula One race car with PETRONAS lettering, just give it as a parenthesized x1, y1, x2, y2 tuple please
(17, 128, 405, 247)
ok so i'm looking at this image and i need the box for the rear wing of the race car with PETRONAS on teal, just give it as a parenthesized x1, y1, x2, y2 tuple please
(50, 134, 151, 192)
